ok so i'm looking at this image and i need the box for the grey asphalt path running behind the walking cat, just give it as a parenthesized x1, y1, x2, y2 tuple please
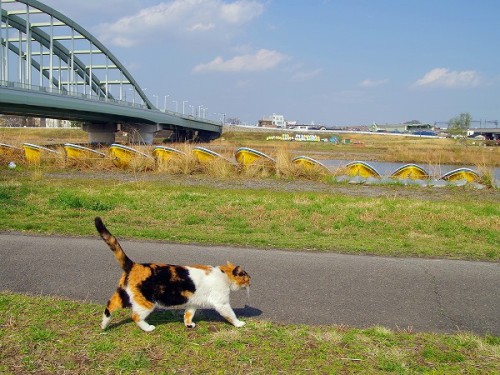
(0, 234, 500, 335)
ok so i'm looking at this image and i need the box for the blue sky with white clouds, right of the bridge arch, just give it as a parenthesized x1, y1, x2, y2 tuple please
(42, 0, 500, 126)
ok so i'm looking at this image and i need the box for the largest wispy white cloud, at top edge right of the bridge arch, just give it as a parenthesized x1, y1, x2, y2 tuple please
(100, 0, 264, 47)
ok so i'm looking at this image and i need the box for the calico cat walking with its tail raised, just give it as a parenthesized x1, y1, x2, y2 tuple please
(95, 217, 250, 332)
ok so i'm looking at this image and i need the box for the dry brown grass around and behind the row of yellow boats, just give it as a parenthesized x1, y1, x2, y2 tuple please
(0, 128, 500, 186)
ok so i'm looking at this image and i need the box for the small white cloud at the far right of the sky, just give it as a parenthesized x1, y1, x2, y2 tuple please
(414, 68, 481, 88)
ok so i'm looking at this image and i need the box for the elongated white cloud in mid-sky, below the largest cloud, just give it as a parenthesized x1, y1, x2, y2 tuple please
(193, 49, 287, 73)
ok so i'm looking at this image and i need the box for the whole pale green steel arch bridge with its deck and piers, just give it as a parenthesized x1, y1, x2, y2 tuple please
(0, 0, 222, 144)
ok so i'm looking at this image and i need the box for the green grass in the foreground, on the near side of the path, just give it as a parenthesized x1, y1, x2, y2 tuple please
(0, 292, 500, 374)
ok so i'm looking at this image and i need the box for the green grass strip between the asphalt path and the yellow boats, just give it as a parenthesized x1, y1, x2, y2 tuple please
(0, 170, 500, 261)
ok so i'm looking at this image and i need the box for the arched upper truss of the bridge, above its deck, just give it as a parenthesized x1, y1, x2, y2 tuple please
(0, 0, 154, 109)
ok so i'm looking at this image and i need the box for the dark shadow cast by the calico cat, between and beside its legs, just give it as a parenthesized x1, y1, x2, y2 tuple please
(108, 305, 262, 329)
